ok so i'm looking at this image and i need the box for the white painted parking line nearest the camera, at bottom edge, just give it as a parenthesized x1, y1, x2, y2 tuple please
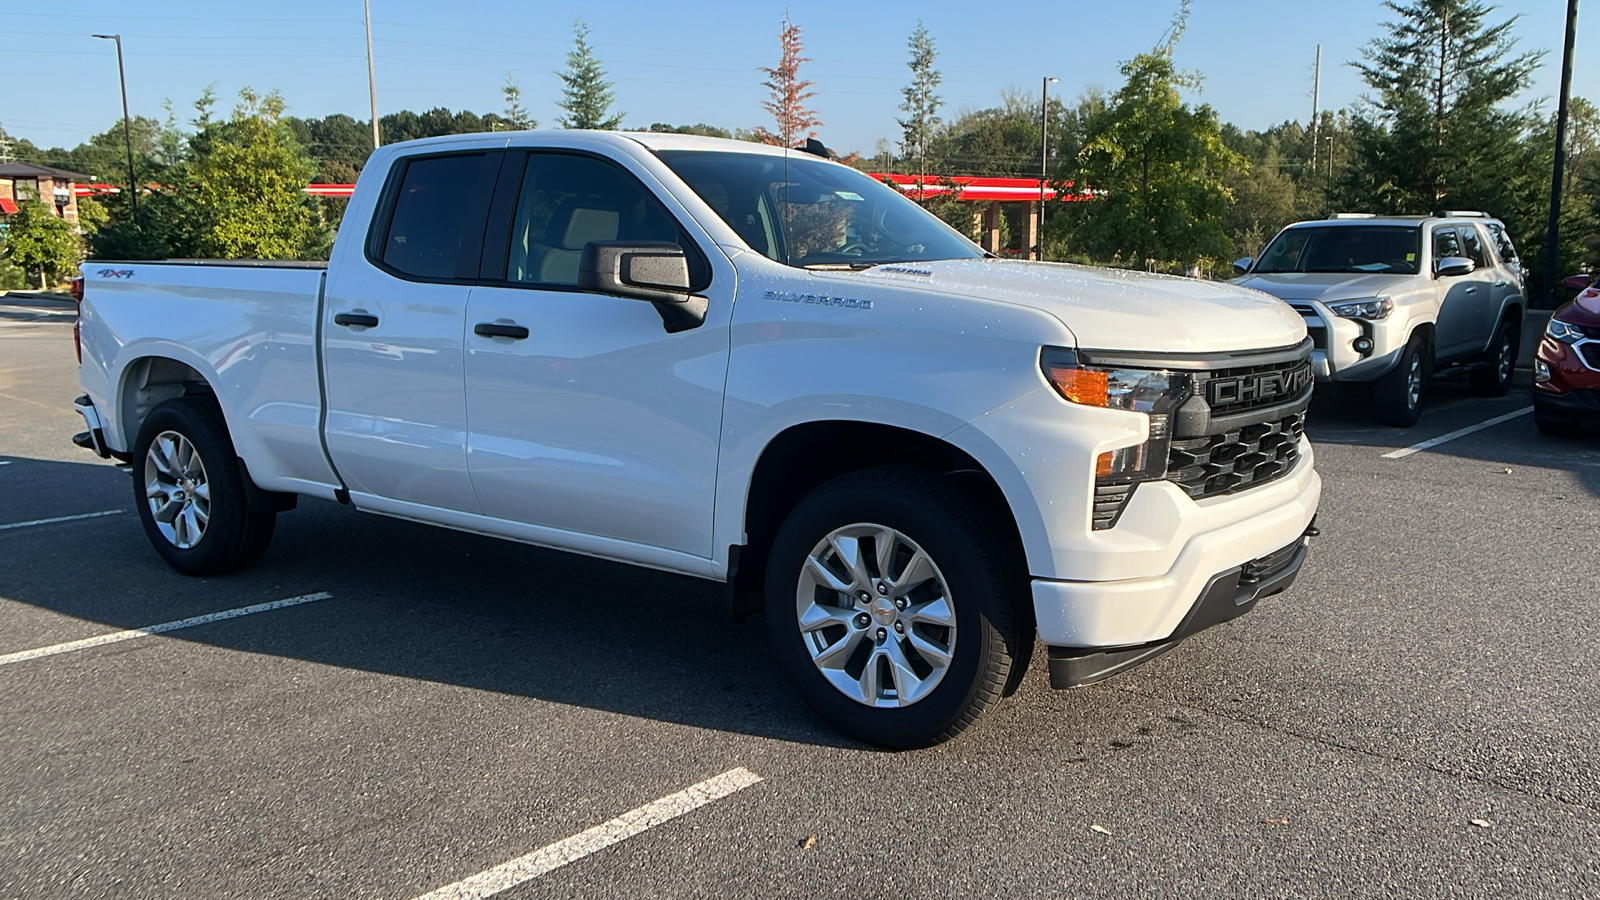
(416, 767, 762, 900)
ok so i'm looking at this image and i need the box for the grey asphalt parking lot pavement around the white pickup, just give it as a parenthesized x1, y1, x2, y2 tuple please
(0, 306, 1600, 898)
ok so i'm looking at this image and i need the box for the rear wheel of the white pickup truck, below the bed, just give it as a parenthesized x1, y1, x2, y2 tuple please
(130, 397, 277, 577)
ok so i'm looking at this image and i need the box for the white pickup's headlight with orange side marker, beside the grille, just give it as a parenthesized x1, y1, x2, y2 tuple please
(1040, 348, 1194, 485)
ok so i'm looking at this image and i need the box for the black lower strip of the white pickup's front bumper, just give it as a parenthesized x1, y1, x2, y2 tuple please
(1048, 525, 1318, 689)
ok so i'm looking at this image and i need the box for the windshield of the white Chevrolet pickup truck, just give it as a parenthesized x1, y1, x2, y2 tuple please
(656, 151, 984, 269)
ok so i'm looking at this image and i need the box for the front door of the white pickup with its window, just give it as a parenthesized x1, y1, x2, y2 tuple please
(466, 152, 733, 559)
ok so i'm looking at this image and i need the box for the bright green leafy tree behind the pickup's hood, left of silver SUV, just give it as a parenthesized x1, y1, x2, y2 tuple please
(1050, 0, 1248, 269)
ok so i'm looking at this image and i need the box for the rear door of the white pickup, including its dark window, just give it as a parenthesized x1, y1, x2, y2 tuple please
(322, 151, 502, 514)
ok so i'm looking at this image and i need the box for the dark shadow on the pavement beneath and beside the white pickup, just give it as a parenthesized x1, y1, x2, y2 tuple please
(0, 456, 861, 748)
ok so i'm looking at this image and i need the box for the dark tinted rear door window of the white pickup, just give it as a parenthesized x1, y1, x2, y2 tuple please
(381, 154, 483, 279)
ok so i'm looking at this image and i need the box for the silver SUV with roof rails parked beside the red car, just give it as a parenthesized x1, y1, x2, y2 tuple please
(1234, 211, 1526, 428)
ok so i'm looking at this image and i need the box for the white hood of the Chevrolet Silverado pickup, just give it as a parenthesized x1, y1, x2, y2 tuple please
(830, 259, 1306, 352)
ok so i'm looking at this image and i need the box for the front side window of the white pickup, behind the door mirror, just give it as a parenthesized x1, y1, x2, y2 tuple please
(506, 154, 710, 290)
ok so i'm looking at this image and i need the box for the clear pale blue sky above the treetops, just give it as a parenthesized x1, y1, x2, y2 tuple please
(0, 0, 1600, 154)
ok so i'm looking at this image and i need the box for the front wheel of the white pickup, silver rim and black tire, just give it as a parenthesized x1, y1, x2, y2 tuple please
(765, 468, 1026, 749)
